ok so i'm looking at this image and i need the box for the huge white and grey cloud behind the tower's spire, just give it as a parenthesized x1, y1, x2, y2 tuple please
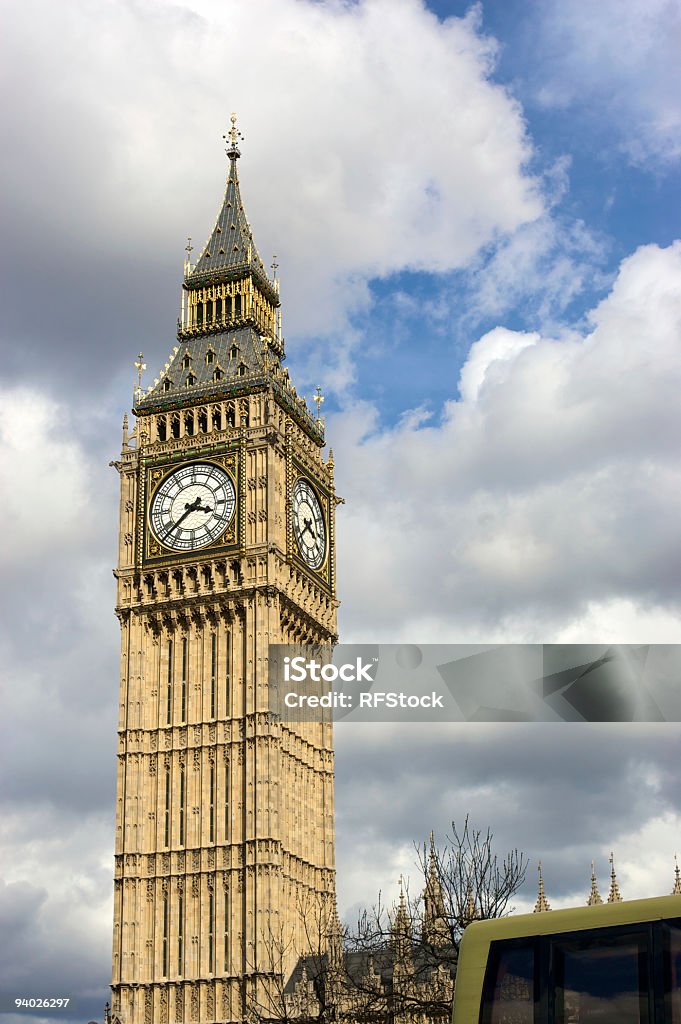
(3, 0, 544, 387)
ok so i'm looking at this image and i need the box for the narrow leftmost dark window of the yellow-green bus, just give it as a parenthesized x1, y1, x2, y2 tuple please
(481, 942, 535, 1024)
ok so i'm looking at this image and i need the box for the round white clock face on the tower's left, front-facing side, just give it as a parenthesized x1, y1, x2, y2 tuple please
(150, 462, 237, 551)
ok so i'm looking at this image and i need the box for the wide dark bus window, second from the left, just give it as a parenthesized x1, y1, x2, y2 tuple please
(553, 933, 649, 1024)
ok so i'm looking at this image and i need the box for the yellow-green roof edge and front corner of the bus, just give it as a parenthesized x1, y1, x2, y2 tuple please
(453, 896, 681, 1024)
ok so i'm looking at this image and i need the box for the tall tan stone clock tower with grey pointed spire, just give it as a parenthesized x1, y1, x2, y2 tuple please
(112, 116, 337, 1024)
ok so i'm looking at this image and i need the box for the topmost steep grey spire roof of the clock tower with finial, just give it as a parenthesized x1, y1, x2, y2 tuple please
(184, 114, 279, 305)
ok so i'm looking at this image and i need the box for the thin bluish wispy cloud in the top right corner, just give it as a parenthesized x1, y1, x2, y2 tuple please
(533, 0, 681, 166)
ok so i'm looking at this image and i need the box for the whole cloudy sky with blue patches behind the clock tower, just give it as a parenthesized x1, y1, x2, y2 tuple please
(0, 0, 681, 1021)
